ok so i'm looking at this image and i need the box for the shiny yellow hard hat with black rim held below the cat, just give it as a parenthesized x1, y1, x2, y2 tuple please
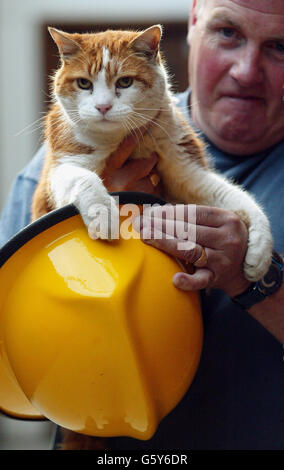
(0, 193, 202, 439)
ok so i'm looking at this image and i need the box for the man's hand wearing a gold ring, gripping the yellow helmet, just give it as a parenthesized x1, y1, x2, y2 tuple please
(134, 205, 250, 297)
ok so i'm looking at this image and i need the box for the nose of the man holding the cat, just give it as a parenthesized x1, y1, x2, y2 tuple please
(230, 45, 264, 87)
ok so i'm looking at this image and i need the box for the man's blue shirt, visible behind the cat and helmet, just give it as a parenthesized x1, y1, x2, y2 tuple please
(0, 92, 284, 451)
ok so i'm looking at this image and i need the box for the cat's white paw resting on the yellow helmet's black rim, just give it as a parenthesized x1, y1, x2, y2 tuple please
(86, 197, 119, 240)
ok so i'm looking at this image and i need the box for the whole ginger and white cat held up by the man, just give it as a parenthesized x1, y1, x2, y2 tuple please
(32, 25, 272, 280)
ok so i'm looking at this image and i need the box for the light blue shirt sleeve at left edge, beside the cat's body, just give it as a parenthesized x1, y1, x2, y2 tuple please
(0, 146, 45, 247)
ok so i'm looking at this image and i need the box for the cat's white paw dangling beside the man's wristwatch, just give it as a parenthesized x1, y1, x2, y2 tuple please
(244, 227, 273, 282)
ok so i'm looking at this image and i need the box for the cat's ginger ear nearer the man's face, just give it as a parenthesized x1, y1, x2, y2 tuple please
(131, 24, 162, 59)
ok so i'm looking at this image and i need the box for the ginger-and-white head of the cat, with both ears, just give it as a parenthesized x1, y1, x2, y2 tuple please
(50, 26, 167, 133)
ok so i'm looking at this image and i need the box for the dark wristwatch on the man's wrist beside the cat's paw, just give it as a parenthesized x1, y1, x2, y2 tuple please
(232, 251, 283, 310)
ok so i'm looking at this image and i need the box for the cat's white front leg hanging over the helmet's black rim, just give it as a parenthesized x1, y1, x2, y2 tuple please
(49, 157, 119, 239)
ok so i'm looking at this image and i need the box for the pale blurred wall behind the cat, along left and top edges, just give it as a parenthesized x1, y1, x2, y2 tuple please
(0, 0, 190, 209)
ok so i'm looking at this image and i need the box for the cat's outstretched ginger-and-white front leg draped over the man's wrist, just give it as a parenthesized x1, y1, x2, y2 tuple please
(160, 160, 273, 281)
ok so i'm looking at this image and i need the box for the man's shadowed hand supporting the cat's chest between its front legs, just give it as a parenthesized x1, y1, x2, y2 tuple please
(101, 132, 161, 196)
